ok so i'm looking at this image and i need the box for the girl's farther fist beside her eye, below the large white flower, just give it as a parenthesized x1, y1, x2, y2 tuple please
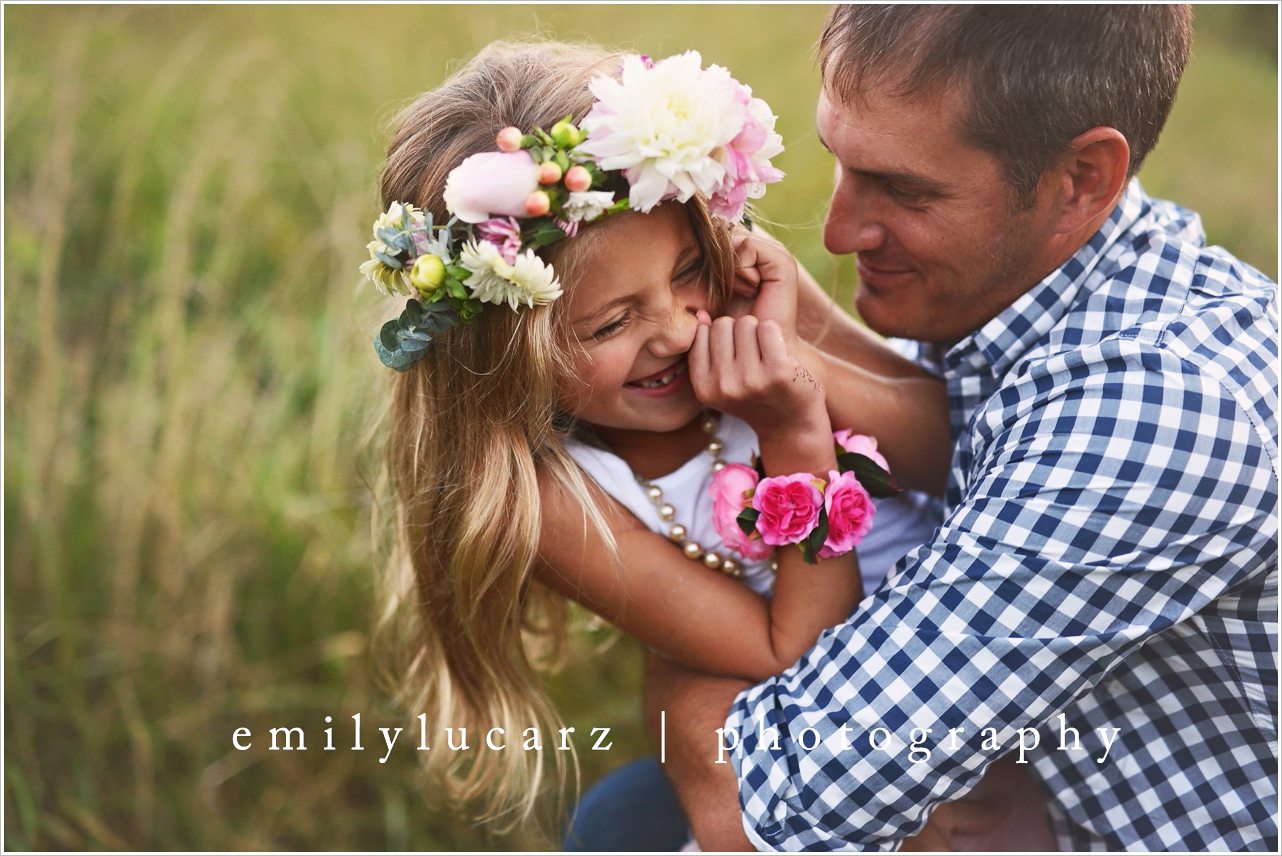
(727, 227, 799, 352)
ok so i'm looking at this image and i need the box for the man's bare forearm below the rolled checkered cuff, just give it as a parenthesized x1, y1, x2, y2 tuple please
(644, 652, 754, 851)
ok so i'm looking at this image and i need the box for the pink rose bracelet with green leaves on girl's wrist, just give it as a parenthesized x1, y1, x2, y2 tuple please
(709, 431, 899, 564)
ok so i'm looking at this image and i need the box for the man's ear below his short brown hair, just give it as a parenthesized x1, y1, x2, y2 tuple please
(1054, 126, 1131, 233)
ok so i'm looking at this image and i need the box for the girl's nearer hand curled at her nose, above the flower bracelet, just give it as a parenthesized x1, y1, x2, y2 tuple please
(687, 310, 832, 447)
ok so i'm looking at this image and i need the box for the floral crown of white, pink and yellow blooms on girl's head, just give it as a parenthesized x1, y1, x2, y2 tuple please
(360, 51, 783, 372)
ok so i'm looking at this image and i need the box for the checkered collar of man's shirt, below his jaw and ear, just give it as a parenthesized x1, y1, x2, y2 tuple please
(944, 178, 1150, 378)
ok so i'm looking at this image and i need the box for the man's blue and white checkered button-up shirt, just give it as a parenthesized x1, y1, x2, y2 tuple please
(726, 182, 1278, 852)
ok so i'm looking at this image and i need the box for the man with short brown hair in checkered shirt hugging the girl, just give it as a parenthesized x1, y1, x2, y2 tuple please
(647, 5, 1278, 851)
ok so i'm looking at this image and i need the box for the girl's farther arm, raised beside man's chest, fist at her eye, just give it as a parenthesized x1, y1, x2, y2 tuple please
(736, 231, 953, 496)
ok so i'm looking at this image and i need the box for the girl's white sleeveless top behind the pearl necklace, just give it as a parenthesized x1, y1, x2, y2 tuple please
(564, 413, 942, 597)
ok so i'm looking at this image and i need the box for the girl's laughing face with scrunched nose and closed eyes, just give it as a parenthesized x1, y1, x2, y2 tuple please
(562, 202, 712, 432)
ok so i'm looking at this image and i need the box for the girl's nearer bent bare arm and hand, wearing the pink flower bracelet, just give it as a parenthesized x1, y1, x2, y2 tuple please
(537, 313, 863, 682)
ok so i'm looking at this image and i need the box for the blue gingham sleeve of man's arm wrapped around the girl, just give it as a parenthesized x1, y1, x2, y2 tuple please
(726, 340, 1277, 851)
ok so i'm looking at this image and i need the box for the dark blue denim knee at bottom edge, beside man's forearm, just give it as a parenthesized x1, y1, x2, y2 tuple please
(563, 757, 690, 852)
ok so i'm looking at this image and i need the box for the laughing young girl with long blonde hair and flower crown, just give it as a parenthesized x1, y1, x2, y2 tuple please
(363, 36, 1046, 845)
